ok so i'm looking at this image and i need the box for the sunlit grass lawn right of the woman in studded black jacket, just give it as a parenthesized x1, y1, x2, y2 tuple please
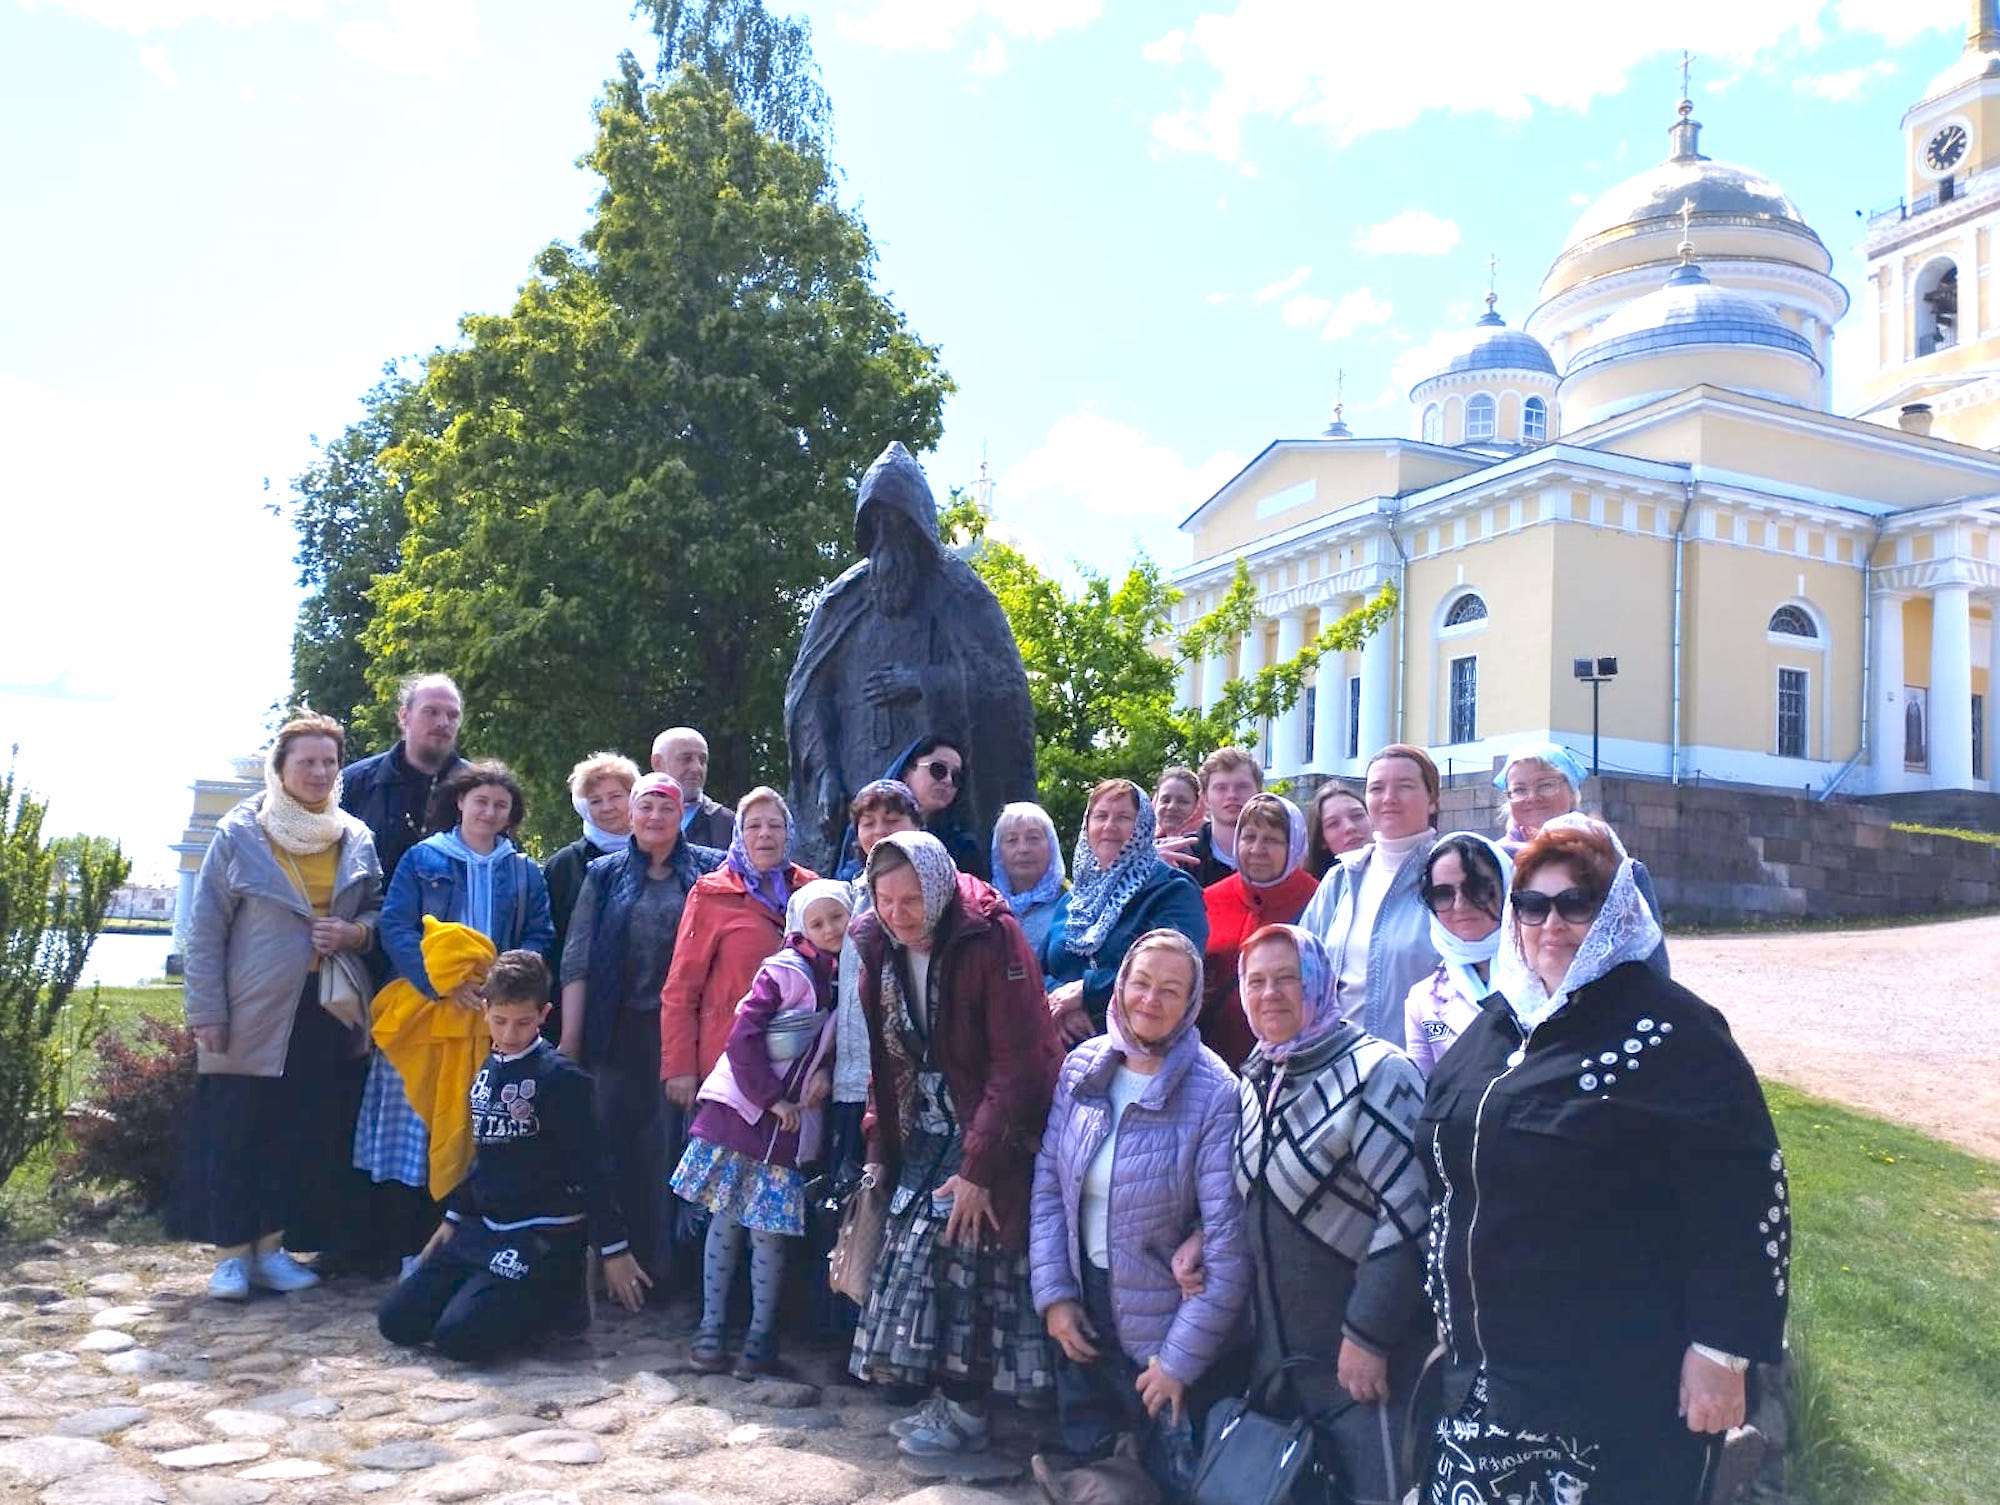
(1764, 1083, 2000, 1505)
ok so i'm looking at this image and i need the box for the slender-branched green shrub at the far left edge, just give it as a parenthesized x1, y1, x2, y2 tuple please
(0, 767, 132, 1181)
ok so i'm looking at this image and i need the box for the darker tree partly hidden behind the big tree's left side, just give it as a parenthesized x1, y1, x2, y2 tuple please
(290, 362, 426, 740)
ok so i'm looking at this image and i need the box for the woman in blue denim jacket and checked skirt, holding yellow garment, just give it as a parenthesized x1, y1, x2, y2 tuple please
(354, 761, 556, 1265)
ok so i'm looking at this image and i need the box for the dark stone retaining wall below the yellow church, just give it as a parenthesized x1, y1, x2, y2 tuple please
(1300, 775, 2000, 927)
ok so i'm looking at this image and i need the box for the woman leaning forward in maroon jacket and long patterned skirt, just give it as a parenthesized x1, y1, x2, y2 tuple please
(848, 831, 1062, 1457)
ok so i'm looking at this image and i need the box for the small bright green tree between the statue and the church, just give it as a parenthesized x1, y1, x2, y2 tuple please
(942, 492, 1396, 841)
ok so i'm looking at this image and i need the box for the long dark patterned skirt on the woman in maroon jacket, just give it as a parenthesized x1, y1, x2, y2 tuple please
(848, 1197, 1056, 1395)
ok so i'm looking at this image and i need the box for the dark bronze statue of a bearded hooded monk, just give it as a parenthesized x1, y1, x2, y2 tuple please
(784, 444, 1036, 877)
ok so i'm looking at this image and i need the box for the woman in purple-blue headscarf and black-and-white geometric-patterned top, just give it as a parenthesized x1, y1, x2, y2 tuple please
(1192, 925, 1432, 1505)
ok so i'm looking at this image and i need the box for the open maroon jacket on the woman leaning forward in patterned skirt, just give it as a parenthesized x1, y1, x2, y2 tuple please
(848, 873, 1062, 1251)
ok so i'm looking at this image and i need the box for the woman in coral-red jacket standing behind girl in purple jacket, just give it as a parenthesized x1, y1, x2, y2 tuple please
(660, 785, 818, 1120)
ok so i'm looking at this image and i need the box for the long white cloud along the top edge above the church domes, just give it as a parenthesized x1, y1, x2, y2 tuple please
(1148, 0, 1964, 162)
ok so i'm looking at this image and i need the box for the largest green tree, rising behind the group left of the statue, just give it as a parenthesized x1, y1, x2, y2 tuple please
(362, 58, 950, 841)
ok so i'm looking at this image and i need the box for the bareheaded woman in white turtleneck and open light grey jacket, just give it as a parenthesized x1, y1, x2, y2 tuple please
(1298, 742, 1440, 1049)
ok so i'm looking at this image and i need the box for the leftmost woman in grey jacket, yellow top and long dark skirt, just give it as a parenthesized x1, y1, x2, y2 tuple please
(168, 714, 382, 1301)
